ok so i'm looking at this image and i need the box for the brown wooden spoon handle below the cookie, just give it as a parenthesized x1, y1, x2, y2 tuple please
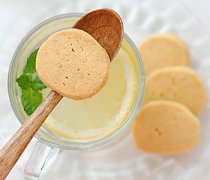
(0, 91, 63, 179)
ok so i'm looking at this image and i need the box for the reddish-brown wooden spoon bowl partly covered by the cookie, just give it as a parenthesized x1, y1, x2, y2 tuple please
(74, 9, 124, 60)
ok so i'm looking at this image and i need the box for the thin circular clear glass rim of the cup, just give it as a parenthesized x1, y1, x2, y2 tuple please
(7, 13, 145, 150)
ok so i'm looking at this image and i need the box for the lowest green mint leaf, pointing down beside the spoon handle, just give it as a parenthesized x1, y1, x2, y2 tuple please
(21, 88, 42, 116)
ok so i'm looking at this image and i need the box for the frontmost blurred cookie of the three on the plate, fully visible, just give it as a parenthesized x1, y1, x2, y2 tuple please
(133, 101, 200, 155)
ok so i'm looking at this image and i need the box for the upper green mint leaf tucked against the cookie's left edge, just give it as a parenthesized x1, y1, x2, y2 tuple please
(23, 49, 39, 74)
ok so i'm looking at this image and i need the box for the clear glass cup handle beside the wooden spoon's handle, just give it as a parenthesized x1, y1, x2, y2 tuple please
(24, 141, 61, 180)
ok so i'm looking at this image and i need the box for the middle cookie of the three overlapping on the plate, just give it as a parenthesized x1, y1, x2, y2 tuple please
(144, 67, 207, 115)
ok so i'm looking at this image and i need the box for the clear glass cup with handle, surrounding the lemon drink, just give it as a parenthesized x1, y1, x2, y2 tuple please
(8, 13, 145, 178)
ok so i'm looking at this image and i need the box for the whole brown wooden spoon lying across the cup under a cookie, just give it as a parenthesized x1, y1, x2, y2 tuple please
(0, 9, 124, 179)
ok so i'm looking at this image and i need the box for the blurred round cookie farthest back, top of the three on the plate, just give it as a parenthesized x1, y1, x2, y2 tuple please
(139, 34, 190, 75)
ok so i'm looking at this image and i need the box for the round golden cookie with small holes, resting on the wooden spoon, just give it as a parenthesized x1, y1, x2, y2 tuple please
(36, 29, 110, 99)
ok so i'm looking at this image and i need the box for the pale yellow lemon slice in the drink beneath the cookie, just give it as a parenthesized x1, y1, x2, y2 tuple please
(43, 47, 136, 140)
